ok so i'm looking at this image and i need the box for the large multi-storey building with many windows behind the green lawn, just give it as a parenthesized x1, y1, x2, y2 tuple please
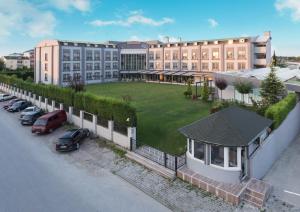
(35, 32, 271, 86)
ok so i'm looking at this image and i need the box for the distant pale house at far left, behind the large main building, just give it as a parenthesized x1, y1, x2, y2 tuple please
(2, 53, 34, 70)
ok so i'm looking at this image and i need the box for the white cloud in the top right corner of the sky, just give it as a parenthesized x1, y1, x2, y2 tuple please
(275, 0, 300, 21)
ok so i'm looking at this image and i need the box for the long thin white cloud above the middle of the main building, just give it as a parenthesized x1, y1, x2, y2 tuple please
(89, 10, 174, 27)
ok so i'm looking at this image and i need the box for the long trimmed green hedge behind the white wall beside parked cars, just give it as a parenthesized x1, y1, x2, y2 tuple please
(0, 74, 137, 126)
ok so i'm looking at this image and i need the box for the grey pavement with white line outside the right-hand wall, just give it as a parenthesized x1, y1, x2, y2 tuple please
(264, 135, 300, 207)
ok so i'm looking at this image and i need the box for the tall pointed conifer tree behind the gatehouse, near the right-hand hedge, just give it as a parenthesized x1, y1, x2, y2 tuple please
(260, 66, 286, 105)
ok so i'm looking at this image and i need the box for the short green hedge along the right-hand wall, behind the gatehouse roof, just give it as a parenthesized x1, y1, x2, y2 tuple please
(265, 93, 297, 128)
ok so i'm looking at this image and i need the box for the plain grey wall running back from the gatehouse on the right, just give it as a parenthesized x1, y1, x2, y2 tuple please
(249, 103, 300, 179)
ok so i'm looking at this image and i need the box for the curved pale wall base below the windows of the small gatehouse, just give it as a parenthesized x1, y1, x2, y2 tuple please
(186, 153, 241, 183)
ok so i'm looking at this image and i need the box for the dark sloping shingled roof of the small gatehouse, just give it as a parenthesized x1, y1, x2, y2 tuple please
(179, 106, 272, 146)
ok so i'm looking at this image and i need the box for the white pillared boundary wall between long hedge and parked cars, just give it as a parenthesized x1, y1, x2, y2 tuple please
(0, 83, 136, 149)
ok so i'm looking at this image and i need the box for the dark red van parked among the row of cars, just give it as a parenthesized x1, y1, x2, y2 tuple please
(31, 110, 67, 134)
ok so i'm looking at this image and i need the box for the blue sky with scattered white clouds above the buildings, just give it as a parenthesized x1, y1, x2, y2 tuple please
(0, 0, 300, 56)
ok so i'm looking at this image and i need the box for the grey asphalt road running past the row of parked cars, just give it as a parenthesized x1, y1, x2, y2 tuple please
(0, 104, 168, 212)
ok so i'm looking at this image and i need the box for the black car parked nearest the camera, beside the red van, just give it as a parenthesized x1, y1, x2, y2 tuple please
(55, 128, 90, 152)
